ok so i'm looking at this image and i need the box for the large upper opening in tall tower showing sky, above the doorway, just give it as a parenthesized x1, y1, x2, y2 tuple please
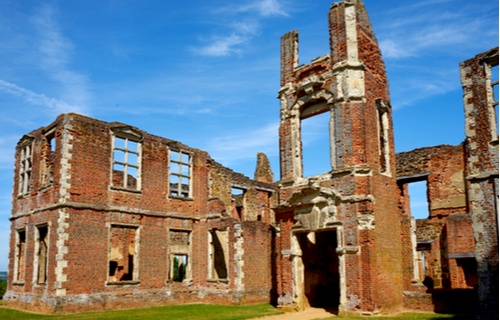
(300, 112, 332, 177)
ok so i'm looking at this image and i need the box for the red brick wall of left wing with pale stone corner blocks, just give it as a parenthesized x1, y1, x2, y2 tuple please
(5, 114, 275, 313)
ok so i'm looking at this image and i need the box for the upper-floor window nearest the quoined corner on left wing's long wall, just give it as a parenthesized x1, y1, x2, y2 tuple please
(112, 135, 142, 190)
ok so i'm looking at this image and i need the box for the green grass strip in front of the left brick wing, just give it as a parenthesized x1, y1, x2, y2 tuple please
(0, 304, 280, 320)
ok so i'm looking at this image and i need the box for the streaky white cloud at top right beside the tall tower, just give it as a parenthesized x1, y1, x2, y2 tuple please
(378, 0, 498, 59)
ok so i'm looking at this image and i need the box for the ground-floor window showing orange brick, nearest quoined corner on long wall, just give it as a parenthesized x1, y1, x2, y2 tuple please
(108, 225, 139, 282)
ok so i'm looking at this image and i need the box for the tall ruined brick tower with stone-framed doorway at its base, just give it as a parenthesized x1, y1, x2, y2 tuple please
(276, 0, 403, 314)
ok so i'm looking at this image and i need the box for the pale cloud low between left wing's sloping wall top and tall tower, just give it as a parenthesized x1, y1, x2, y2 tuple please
(205, 123, 279, 165)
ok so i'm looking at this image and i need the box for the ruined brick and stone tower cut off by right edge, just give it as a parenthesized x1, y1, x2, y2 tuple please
(460, 47, 499, 319)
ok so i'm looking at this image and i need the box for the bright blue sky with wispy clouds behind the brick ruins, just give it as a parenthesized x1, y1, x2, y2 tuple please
(0, 0, 499, 270)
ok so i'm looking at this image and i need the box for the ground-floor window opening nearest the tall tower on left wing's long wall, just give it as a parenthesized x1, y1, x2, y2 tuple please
(209, 229, 228, 280)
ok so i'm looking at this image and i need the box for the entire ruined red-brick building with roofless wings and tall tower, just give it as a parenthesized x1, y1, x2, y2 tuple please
(5, 0, 498, 319)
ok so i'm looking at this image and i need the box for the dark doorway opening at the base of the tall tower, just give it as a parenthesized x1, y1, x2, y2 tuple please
(298, 231, 340, 308)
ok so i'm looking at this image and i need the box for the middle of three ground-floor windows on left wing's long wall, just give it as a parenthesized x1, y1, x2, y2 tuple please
(168, 230, 191, 282)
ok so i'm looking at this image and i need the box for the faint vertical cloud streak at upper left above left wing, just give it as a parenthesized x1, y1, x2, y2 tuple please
(33, 4, 90, 112)
